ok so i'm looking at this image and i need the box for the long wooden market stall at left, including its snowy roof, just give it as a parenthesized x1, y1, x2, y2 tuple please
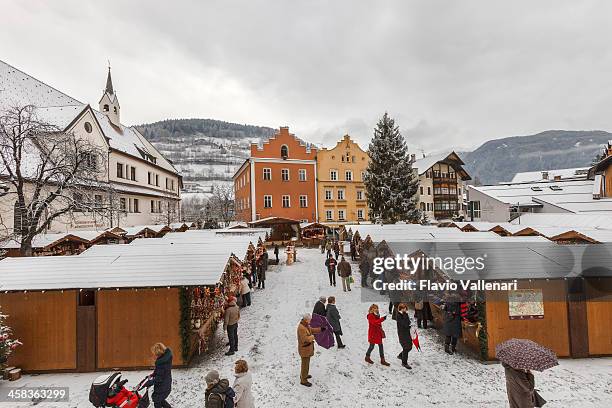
(0, 231, 252, 372)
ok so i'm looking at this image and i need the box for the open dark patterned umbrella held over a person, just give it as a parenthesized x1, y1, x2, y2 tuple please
(495, 339, 559, 371)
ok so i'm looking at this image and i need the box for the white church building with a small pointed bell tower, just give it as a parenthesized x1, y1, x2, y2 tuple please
(0, 61, 182, 232)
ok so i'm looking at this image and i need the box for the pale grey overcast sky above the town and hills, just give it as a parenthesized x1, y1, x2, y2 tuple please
(0, 0, 612, 151)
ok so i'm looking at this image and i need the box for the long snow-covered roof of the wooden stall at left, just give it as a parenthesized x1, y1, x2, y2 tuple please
(0, 231, 253, 291)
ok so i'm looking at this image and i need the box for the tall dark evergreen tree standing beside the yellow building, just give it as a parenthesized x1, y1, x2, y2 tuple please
(364, 112, 421, 224)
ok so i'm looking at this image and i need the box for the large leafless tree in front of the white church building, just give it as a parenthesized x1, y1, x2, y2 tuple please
(0, 105, 118, 256)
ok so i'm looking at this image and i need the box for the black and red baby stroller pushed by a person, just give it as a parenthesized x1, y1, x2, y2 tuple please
(89, 372, 150, 408)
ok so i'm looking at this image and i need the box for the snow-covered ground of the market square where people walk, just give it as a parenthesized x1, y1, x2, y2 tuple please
(0, 249, 612, 408)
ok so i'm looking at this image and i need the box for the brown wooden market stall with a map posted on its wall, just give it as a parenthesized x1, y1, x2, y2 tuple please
(378, 241, 612, 359)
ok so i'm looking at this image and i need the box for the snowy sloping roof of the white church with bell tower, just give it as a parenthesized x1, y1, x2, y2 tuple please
(0, 60, 176, 173)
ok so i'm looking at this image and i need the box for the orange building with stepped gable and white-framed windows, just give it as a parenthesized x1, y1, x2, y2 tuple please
(233, 127, 317, 222)
